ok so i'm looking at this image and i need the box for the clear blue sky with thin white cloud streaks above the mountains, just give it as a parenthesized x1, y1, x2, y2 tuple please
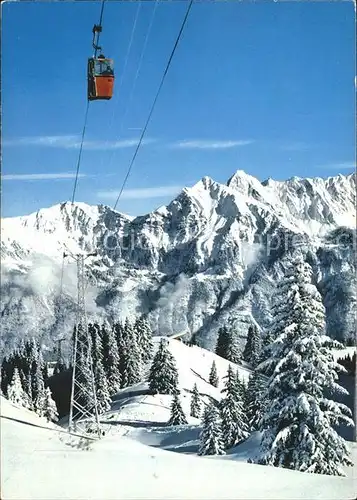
(1, 0, 355, 217)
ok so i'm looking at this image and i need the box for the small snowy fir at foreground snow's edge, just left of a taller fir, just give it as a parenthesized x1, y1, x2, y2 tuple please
(198, 402, 225, 455)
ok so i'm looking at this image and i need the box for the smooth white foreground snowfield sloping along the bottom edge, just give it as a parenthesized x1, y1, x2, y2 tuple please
(1, 397, 357, 500)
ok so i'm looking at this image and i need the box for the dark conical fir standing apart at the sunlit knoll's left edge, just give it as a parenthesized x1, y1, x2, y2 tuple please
(149, 339, 178, 394)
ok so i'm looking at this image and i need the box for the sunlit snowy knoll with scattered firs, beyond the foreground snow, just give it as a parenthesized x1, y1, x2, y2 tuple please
(81, 337, 357, 454)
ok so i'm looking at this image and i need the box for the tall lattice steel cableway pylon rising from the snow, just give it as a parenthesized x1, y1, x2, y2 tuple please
(64, 253, 101, 437)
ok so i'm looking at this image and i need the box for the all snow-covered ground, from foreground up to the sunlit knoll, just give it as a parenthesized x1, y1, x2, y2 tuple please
(1, 338, 357, 500)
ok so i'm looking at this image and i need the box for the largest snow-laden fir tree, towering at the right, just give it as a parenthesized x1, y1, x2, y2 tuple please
(255, 257, 353, 476)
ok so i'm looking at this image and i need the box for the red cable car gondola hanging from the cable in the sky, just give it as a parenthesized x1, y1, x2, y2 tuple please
(88, 24, 114, 101)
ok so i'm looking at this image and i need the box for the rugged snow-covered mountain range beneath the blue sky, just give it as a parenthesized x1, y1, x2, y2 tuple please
(1, 171, 356, 356)
